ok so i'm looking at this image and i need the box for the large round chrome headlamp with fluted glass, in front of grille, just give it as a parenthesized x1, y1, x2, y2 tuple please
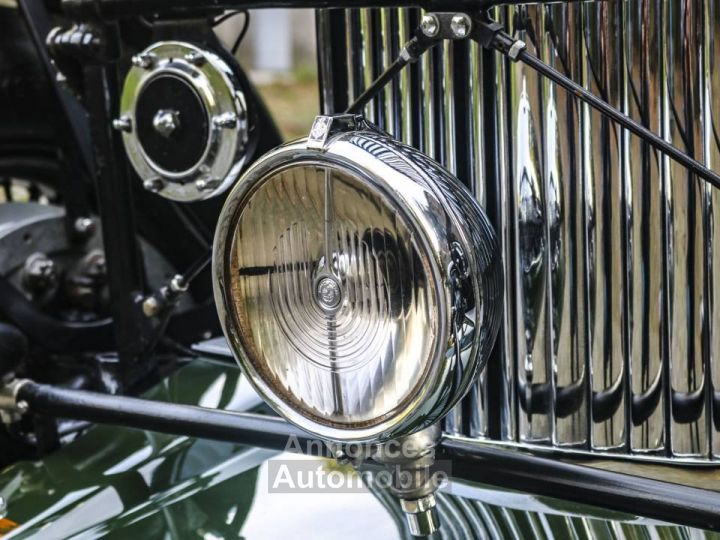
(213, 117, 501, 442)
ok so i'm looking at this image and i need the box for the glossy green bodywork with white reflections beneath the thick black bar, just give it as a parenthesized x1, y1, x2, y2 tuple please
(0, 359, 720, 540)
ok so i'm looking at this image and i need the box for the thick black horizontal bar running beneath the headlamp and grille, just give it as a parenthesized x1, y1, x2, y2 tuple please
(17, 382, 720, 530)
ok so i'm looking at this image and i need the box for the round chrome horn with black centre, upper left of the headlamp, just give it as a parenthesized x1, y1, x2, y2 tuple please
(113, 41, 248, 202)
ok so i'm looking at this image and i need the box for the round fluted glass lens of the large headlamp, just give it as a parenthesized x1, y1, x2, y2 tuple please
(230, 165, 438, 427)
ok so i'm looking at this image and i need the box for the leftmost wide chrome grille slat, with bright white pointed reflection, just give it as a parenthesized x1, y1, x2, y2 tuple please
(508, 5, 554, 443)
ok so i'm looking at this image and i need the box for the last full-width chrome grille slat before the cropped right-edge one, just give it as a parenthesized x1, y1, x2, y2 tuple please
(662, 0, 707, 456)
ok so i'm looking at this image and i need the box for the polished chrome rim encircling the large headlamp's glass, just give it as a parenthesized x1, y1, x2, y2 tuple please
(213, 127, 497, 442)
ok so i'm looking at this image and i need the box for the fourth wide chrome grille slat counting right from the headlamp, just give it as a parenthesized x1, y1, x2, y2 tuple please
(624, 1, 665, 452)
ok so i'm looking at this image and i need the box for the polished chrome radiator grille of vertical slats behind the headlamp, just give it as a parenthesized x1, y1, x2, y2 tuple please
(318, 0, 720, 464)
